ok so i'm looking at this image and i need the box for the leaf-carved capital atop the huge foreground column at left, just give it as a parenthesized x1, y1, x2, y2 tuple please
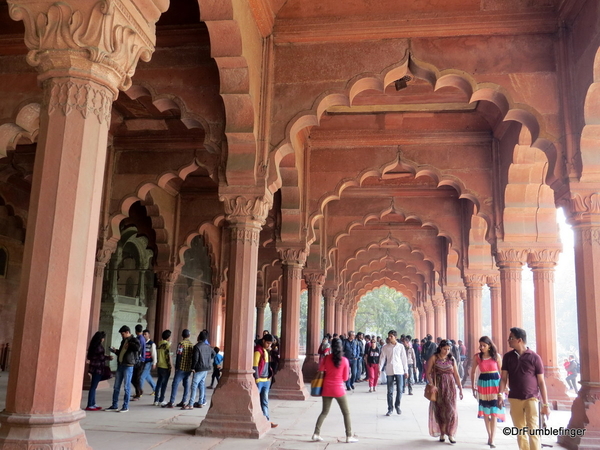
(8, 0, 169, 92)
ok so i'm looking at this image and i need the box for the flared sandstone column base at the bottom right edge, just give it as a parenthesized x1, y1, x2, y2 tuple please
(558, 382, 600, 450)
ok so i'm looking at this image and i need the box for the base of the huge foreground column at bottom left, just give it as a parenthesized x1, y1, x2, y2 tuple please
(0, 410, 91, 450)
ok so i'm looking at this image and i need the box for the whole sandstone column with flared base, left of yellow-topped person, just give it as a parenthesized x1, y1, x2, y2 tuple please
(196, 195, 272, 438)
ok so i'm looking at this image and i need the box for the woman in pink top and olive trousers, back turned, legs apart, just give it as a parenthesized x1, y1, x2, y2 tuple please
(312, 338, 358, 443)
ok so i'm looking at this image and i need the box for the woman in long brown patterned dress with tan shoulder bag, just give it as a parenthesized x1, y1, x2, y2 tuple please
(426, 339, 463, 444)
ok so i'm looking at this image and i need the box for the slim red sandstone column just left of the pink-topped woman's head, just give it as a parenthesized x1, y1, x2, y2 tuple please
(302, 270, 325, 381)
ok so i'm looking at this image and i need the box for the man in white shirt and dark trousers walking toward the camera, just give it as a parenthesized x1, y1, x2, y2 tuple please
(379, 330, 408, 416)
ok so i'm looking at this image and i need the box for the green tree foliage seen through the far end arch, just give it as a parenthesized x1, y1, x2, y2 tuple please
(354, 286, 415, 336)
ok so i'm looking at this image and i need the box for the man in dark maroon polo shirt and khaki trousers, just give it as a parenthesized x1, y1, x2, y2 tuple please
(498, 327, 550, 450)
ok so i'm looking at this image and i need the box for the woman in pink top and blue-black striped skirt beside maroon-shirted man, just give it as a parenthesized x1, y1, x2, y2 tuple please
(471, 336, 504, 448)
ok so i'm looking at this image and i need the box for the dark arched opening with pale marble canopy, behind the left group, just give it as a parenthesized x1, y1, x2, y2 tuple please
(100, 227, 154, 370)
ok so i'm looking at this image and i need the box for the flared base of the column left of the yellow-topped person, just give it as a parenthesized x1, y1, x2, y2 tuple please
(196, 373, 271, 439)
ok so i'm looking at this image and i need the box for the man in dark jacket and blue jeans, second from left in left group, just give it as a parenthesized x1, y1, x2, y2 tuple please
(104, 325, 140, 412)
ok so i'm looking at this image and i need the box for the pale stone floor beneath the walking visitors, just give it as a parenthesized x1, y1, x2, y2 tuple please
(0, 373, 570, 450)
